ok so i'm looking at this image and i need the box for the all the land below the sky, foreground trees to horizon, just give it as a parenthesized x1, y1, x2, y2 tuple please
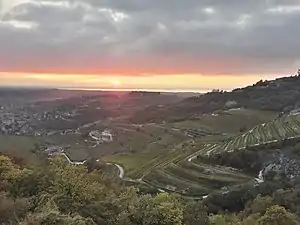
(4, 74, 300, 225)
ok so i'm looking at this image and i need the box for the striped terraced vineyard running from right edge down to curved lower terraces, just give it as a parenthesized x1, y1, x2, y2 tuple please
(139, 115, 300, 196)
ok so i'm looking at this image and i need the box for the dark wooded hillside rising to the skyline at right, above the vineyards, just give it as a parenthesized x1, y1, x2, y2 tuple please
(131, 76, 300, 123)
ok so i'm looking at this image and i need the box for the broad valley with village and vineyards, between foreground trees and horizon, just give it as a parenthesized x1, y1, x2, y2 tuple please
(0, 75, 300, 199)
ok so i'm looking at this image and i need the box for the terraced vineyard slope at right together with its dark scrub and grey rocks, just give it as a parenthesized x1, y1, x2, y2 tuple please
(128, 113, 300, 197)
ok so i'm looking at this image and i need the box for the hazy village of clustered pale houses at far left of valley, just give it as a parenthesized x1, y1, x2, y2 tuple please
(0, 99, 82, 136)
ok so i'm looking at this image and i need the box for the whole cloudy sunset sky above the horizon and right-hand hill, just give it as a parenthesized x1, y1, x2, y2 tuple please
(0, 0, 300, 91)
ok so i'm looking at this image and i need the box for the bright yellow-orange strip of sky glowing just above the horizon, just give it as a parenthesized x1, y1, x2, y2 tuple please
(0, 73, 286, 92)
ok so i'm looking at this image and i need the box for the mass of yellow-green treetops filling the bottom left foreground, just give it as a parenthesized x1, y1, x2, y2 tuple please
(0, 156, 207, 225)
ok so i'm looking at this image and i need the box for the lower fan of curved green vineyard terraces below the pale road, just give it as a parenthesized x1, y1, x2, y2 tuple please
(143, 145, 253, 196)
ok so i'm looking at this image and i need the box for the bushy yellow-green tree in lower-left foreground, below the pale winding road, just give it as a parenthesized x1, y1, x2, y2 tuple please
(47, 158, 110, 213)
